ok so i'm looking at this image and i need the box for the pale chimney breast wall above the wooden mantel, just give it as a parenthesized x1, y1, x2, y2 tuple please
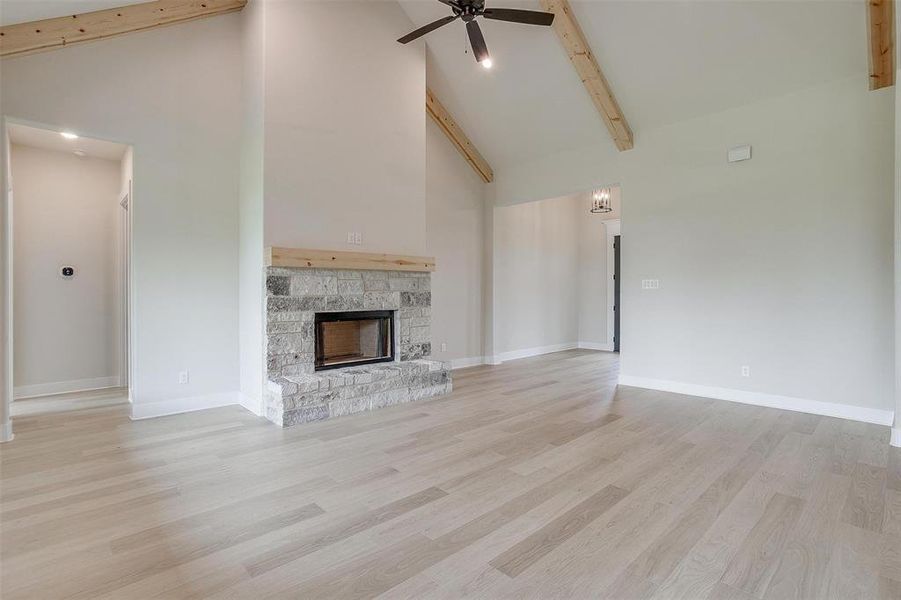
(264, 0, 426, 255)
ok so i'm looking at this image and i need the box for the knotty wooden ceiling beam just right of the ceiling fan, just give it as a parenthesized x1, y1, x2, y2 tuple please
(541, 0, 634, 150)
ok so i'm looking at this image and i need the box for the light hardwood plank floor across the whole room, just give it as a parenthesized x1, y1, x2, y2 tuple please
(0, 351, 901, 600)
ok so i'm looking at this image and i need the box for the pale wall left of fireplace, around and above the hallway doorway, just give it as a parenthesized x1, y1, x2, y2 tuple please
(0, 14, 242, 417)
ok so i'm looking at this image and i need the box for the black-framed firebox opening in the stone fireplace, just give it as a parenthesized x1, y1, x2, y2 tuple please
(316, 310, 394, 371)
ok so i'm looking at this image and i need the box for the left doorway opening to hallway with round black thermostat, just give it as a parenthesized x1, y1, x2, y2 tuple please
(6, 121, 132, 416)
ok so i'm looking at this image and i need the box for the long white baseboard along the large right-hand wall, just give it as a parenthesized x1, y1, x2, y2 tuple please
(619, 375, 901, 426)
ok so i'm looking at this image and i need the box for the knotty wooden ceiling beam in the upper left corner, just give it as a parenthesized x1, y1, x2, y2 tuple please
(0, 0, 247, 57)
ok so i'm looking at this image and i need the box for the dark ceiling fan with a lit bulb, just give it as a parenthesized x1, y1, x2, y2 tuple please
(397, 0, 554, 69)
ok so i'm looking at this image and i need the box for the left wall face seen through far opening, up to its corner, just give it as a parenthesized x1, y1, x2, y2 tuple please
(494, 197, 579, 360)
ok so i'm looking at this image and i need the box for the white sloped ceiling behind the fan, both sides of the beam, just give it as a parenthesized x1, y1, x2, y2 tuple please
(398, 0, 867, 168)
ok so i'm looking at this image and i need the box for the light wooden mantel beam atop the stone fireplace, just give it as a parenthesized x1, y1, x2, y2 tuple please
(265, 247, 435, 271)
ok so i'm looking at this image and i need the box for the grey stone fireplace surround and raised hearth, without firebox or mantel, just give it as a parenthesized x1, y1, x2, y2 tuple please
(266, 267, 452, 426)
